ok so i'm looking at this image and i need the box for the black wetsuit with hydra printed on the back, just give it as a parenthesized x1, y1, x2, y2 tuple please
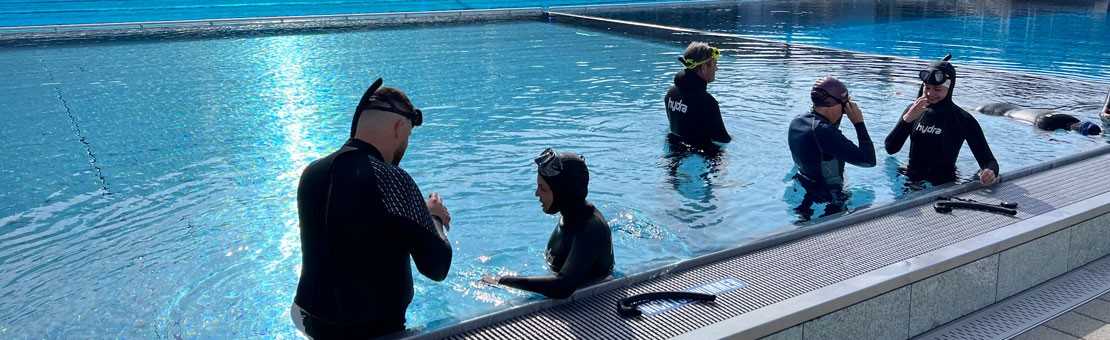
(664, 70, 733, 146)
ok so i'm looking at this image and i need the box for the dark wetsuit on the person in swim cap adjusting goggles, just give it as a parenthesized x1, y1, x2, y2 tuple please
(787, 111, 875, 202)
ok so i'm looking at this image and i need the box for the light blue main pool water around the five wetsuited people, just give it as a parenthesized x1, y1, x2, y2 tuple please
(0, 9, 1106, 338)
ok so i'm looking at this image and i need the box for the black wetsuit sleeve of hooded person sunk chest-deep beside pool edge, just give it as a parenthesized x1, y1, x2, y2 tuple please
(498, 226, 608, 299)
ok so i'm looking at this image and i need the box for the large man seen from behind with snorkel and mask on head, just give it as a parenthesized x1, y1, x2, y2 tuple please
(291, 79, 451, 339)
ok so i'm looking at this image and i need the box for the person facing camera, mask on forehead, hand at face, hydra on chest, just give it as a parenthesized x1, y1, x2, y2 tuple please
(886, 57, 998, 186)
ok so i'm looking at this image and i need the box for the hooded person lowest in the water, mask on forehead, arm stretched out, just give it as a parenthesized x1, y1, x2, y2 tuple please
(482, 149, 613, 299)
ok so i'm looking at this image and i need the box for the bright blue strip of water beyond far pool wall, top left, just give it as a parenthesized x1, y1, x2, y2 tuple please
(0, 0, 662, 27)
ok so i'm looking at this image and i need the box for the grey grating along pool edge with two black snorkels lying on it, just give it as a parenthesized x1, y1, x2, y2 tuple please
(414, 148, 1110, 339)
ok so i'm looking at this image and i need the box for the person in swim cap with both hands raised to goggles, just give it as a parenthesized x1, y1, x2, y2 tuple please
(787, 77, 875, 219)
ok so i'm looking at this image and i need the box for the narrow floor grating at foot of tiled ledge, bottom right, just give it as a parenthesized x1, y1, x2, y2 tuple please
(914, 253, 1110, 340)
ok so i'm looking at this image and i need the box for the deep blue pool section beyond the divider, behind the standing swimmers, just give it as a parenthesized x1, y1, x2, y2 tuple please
(604, 0, 1110, 80)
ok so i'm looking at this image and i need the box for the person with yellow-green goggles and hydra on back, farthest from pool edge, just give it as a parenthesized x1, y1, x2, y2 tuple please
(664, 42, 733, 146)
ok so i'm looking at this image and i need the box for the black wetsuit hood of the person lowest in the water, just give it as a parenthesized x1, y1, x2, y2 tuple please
(539, 152, 592, 217)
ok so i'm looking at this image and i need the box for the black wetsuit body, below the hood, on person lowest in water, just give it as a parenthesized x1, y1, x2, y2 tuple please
(498, 203, 613, 299)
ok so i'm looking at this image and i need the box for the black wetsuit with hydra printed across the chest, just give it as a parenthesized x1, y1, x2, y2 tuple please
(886, 85, 999, 184)
